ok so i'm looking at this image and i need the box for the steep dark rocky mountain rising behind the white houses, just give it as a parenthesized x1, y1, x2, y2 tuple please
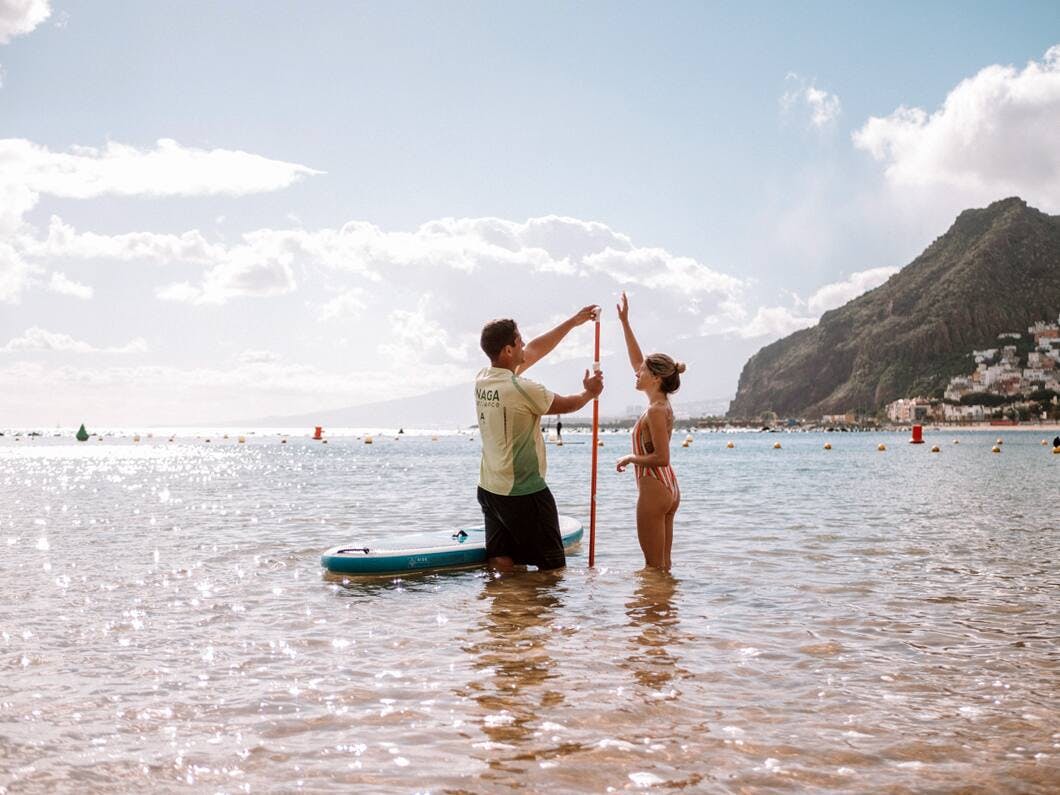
(728, 197, 1060, 418)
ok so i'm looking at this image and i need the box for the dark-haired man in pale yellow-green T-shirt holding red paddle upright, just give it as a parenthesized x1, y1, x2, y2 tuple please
(475, 305, 603, 571)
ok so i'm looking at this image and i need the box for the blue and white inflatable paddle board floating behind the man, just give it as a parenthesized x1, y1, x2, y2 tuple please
(320, 516, 584, 575)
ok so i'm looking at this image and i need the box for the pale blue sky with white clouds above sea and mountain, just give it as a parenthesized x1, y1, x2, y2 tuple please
(0, 0, 1060, 427)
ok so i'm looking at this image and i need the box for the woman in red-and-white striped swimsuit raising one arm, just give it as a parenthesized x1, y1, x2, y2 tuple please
(616, 293, 685, 569)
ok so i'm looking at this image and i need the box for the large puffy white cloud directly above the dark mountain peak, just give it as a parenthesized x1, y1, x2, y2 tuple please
(853, 45, 1060, 209)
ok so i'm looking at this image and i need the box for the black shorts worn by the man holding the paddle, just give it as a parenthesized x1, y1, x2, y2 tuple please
(478, 487, 567, 570)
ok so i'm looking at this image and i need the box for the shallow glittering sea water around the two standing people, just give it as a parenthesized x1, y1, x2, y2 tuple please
(0, 430, 1060, 793)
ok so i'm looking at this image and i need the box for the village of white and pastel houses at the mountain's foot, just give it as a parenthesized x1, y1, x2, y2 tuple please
(885, 317, 1060, 425)
